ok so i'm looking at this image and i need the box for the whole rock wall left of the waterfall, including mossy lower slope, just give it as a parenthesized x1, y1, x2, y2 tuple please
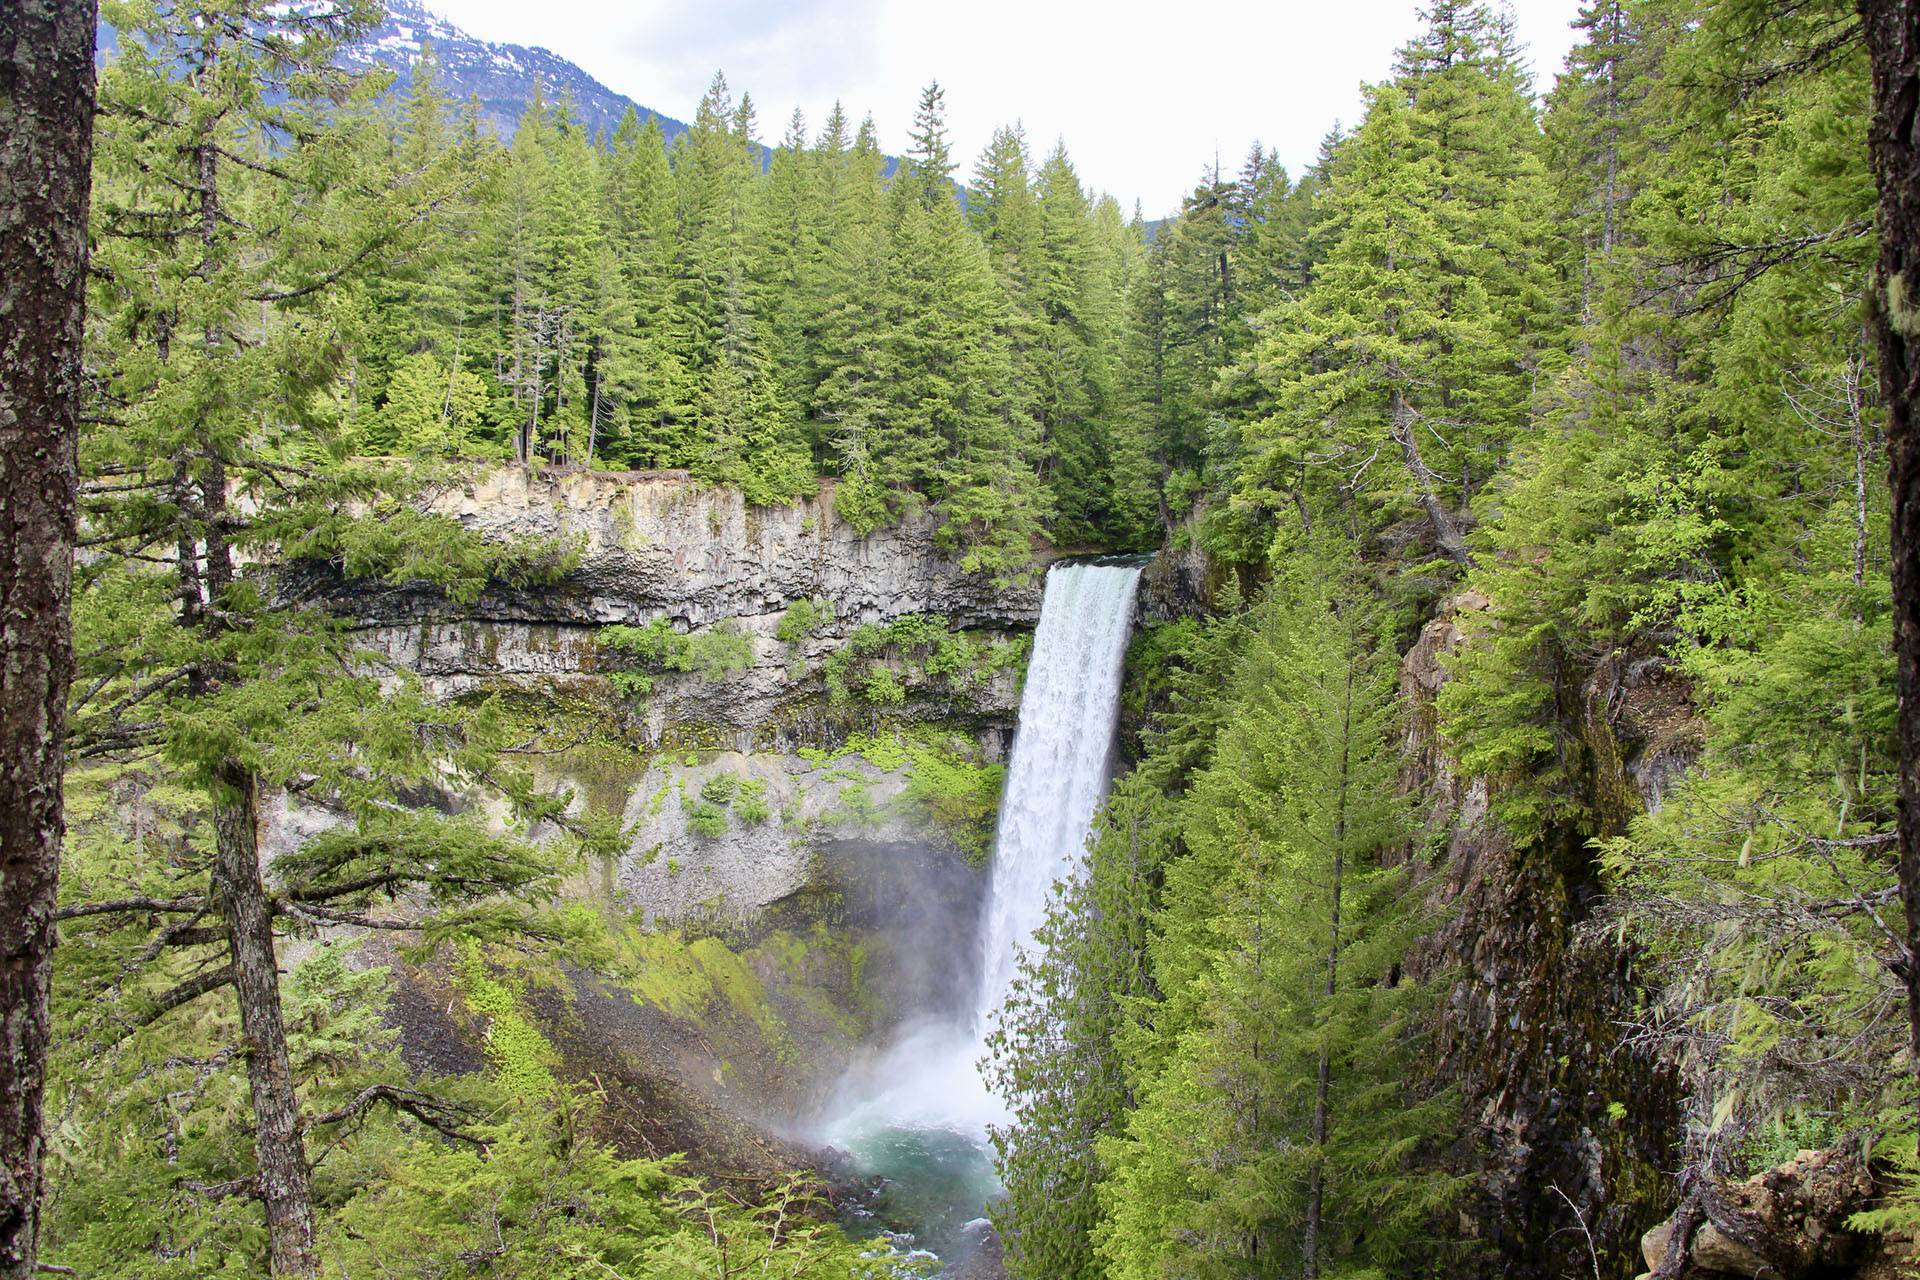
(282, 468, 1059, 1169)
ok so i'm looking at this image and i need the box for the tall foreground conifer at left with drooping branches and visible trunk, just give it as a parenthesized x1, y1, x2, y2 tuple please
(74, 0, 595, 1276)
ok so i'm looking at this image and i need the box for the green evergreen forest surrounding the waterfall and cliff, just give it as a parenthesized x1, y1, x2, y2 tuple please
(7, 0, 1920, 1280)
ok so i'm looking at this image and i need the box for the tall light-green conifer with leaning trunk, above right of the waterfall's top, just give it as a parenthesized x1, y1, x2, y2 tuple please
(1242, 4, 1555, 564)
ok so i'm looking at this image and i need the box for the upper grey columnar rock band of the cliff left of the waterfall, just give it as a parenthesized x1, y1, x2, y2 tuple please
(309, 468, 1041, 758)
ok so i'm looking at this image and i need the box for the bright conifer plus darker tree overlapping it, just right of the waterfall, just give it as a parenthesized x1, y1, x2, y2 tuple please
(991, 537, 1461, 1278)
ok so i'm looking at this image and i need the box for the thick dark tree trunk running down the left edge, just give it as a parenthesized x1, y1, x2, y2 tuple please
(0, 0, 96, 1280)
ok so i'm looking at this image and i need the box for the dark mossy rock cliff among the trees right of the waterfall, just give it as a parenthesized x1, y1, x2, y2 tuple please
(1402, 593, 1699, 1280)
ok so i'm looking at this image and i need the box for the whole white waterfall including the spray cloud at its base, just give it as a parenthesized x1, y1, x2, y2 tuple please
(826, 564, 1140, 1151)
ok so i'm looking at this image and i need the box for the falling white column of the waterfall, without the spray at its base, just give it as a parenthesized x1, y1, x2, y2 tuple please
(970, 564, 1140, 1050)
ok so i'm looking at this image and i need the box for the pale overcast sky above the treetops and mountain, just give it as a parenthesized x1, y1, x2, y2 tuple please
(426, 0, 1578, 217)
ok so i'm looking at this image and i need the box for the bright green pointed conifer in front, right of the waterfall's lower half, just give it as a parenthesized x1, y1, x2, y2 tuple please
(1094, 556, 1455, 1280)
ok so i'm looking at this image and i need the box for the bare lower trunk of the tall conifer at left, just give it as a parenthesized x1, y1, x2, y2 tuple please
(213, 766, 319, 1276)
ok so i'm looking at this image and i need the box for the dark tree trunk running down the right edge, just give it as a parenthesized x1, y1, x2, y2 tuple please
(1859, 0, 1920, 1166)
